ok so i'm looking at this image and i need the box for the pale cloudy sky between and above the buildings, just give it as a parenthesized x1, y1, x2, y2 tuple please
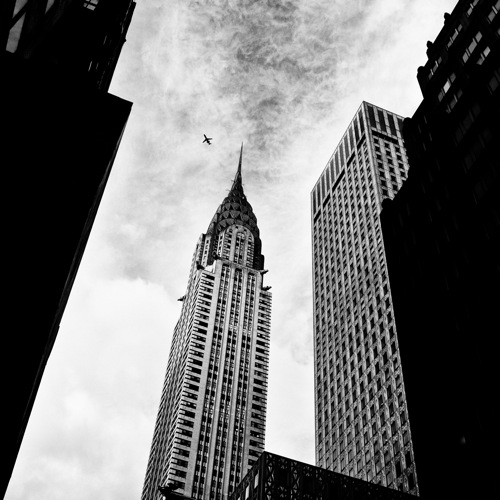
(6, 0, 456, 500)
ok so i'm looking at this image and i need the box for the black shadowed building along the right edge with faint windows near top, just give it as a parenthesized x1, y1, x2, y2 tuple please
(381, 0, 500, 499)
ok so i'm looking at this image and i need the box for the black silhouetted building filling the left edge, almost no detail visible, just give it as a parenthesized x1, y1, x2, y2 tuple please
(0, 0, 135, 496)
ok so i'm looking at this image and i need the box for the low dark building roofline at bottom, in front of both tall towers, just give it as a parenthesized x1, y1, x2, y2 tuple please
(229, 451, 415, 500)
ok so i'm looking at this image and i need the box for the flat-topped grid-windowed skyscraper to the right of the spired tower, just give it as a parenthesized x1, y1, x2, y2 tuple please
(311, 102, 418, 494)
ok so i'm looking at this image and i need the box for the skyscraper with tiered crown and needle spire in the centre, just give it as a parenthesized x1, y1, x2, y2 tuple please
(142, 146, 271, 500)
